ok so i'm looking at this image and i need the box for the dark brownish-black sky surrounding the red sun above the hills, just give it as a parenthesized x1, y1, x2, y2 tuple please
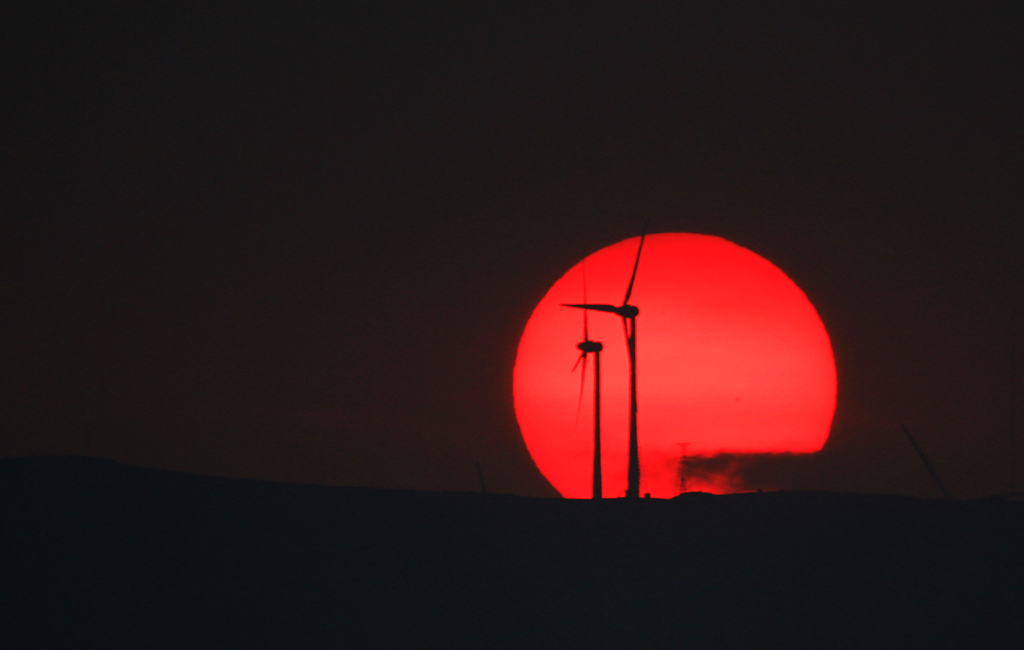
(0, 1, 1024, 496)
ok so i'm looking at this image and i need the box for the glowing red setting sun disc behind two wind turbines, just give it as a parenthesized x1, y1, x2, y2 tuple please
(513, 232, 836, 497)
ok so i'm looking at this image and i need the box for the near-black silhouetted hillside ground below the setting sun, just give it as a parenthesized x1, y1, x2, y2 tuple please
(0, 458, 1024, 649)
